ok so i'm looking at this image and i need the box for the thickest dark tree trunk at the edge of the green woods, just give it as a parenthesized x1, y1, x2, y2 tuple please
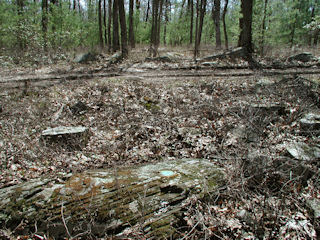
(238, 0, 253, 54)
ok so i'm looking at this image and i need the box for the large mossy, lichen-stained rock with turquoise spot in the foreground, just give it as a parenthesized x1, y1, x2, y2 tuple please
(0, 159, 224, 239)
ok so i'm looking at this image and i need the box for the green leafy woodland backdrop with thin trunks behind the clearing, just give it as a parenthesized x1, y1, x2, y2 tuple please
(0, 0, 320, 63)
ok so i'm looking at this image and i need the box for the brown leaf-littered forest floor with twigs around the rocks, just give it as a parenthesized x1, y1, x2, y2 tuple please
(0, 46, 320, 239)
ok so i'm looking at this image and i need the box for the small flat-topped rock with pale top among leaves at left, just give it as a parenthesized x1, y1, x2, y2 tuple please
(41, 126, 89, 150)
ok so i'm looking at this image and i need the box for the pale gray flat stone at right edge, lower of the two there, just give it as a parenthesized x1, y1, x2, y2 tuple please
(286, 142, 320, 161)
